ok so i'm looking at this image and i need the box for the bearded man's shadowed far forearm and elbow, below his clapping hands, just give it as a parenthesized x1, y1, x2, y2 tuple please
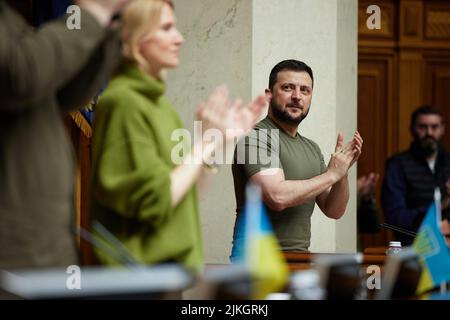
(324, 176, 349, 219)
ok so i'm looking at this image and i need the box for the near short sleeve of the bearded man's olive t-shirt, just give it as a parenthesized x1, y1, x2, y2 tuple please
(235, 129, 282, 178)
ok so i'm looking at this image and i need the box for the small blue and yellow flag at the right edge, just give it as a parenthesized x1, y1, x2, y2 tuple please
(413, 202, 450, 294)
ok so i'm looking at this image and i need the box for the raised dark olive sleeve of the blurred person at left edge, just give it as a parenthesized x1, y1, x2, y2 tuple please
(0, 4, 109, 110)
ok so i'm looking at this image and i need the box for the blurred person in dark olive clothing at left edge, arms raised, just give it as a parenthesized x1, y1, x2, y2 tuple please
(0, 0, 128, 269)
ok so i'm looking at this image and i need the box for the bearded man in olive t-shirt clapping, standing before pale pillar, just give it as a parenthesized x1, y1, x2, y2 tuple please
(231, 60, 362, 261)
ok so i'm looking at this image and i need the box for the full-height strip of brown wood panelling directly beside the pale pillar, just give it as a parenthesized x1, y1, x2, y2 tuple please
(358, 0, 398, 250)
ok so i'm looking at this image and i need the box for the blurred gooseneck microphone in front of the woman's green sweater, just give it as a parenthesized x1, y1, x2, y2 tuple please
(75, 221, 140, 268)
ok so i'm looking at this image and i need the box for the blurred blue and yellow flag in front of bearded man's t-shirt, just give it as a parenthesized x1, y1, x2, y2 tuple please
(239, 184, 289, 299)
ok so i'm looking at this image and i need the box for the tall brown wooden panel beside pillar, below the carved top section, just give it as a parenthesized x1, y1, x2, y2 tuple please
(358, 50, 397, 250)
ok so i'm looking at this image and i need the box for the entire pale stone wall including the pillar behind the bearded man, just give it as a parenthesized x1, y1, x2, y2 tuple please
(168, 0, 357, 263)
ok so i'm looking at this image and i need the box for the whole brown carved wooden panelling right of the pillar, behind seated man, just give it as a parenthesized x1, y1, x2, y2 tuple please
(358, 0, 450, 249)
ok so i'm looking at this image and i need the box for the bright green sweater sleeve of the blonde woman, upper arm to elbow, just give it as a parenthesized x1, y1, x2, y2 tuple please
(93, 92, 173, 224)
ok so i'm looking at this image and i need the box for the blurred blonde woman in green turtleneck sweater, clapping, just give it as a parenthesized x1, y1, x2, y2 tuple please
(91, 0, 265, 270)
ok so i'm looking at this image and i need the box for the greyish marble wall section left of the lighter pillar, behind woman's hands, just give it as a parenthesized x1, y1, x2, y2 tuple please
(168, 0, 252, 263)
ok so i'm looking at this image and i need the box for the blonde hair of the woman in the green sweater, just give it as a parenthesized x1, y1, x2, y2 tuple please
(121, 0, 173, 67)
